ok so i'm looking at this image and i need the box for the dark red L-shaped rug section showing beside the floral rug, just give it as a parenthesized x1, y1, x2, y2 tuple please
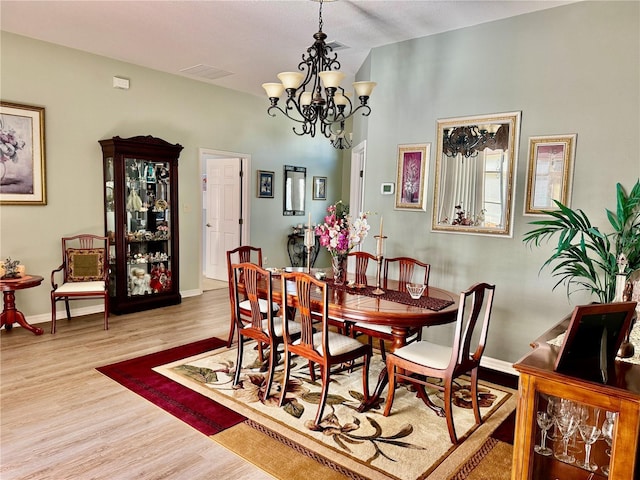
(96, 338, 246, 435)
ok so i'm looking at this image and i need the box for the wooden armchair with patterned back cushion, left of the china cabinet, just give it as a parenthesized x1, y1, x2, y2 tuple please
(51, 234, 109, 333)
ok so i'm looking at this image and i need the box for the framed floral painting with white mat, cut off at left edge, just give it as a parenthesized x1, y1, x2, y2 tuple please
(0, 102, 47, 205)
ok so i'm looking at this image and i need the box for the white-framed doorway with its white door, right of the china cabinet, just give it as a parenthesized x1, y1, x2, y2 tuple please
(200, 149, 251, 282)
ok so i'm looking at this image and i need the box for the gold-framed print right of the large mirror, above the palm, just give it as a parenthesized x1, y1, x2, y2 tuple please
(524, 134, 576, 215)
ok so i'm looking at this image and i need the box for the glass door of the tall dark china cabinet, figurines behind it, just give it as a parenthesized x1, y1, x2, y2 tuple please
(124, 158, 172, 297)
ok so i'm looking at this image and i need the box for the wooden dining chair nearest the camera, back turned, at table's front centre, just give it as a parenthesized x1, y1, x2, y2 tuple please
(280, 272, 371, 425)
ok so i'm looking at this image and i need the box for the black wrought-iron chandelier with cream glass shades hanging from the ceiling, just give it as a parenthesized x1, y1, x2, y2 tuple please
(262, 0, 376, 149)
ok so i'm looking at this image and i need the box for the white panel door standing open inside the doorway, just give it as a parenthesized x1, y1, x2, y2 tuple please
(204, 158, 242, 280)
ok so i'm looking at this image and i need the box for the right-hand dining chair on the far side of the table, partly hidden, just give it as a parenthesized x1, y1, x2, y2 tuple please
(350, 255, 431, 359)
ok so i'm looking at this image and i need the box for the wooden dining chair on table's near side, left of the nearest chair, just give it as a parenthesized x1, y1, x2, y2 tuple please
(231, 263, 300, 400)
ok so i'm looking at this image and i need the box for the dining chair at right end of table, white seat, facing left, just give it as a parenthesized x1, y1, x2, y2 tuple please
(384, 283, 495, 444)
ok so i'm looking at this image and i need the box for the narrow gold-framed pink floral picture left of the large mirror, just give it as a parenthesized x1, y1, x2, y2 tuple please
(395, 143, 431, 210)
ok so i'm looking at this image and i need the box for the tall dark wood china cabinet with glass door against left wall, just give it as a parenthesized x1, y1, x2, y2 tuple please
(99, 136, 182, 314)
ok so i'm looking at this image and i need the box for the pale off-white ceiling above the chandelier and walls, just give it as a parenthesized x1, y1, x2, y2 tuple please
(0, 0, 575, 95)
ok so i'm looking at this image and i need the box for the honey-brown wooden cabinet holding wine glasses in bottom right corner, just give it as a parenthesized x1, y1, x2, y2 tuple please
(511, 318, 640, 480)
